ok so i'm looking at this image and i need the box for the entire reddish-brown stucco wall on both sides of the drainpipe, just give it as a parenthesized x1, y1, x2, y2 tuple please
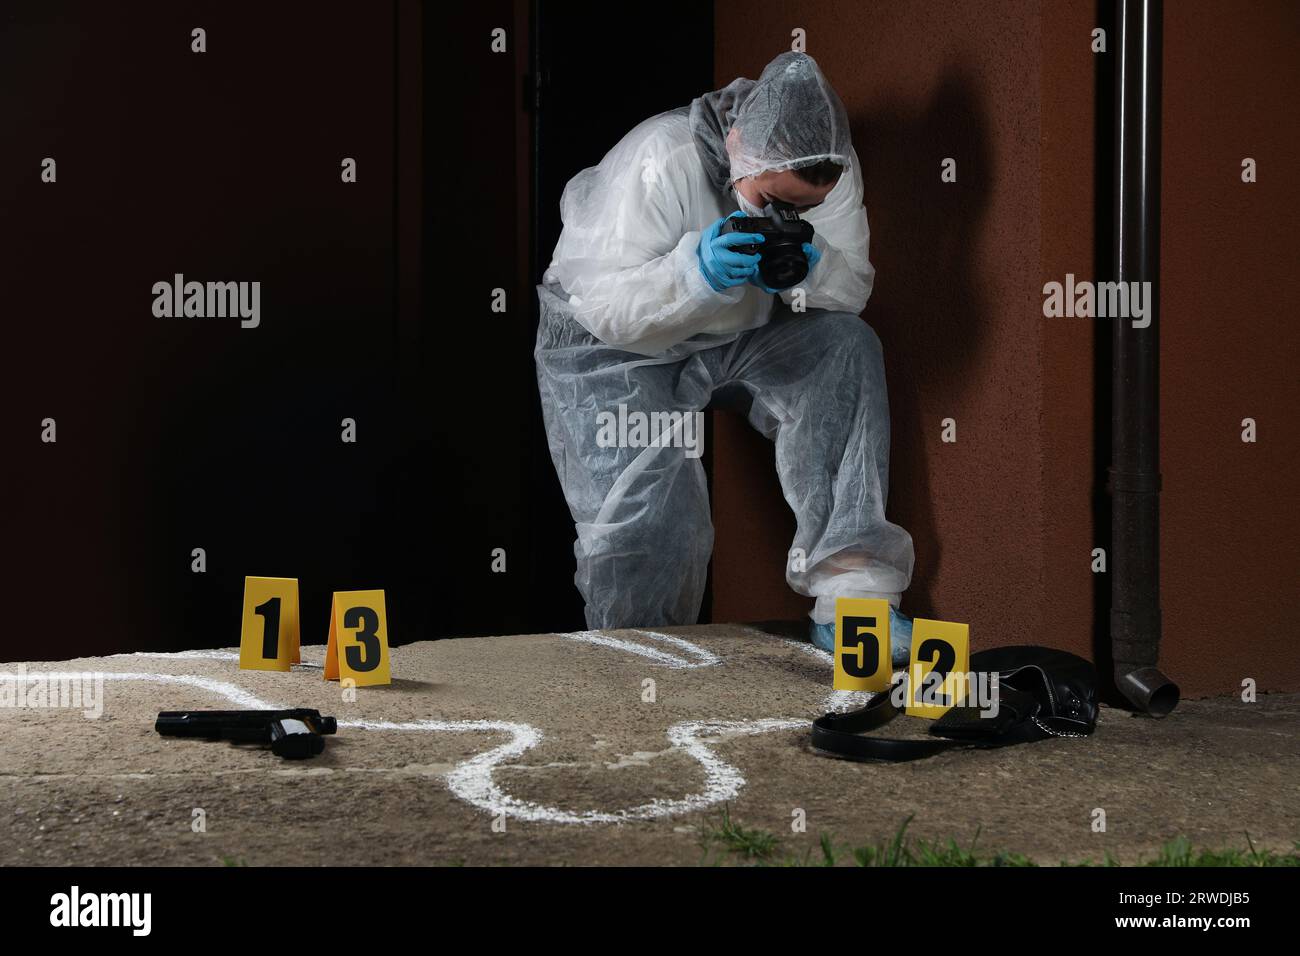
(712, 0, 1300, 696)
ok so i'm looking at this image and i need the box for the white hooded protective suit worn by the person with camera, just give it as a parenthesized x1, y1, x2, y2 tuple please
(534, 53, 913, 628)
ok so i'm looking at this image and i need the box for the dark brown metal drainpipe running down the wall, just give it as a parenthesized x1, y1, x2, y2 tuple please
(1099, 0, 1178, 717)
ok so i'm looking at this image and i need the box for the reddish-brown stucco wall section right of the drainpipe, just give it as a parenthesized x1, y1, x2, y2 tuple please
(1160, 0, 1300, 692)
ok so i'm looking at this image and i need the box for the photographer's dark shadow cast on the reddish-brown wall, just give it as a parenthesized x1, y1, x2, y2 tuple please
(850, 68, 992, 617)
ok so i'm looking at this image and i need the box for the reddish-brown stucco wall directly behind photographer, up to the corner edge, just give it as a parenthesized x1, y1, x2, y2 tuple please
(712, 1, 1050, 658)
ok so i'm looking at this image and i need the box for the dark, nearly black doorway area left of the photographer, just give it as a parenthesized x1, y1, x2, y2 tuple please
(0, 0, 712, 659)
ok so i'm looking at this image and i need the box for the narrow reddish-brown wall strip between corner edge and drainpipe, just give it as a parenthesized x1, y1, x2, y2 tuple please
(1027, 3, 1113, 686)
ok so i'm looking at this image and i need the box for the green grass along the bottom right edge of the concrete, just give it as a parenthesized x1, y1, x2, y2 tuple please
(699, 805, 1300, 866)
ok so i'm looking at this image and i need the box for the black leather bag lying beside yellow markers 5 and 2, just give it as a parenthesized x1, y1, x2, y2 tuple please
(813, 644, 1097, 761)
